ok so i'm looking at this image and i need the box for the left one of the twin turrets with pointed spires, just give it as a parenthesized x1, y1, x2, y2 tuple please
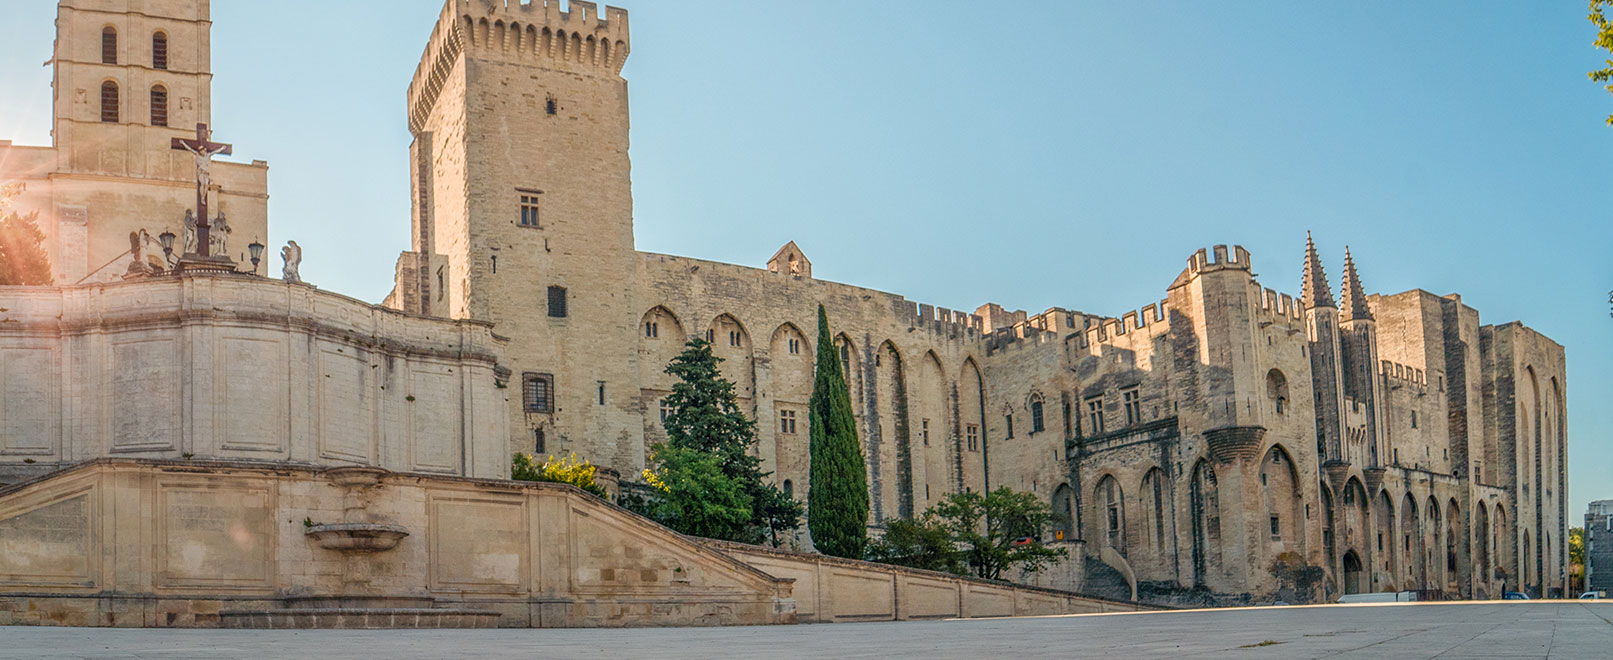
(1300, 232, 1344, 465)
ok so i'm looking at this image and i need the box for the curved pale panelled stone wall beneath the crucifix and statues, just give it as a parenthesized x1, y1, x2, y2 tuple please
(0, 276, 510, 481)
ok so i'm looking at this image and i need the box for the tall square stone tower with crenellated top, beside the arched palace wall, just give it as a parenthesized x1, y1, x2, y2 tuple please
(387, 0, 642, 465)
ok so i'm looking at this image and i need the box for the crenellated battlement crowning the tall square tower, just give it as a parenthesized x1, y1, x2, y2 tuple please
(408, 0, 632, 131)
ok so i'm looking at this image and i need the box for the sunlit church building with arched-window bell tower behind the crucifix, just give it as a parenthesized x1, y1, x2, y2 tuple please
(0, 0, 269, 284)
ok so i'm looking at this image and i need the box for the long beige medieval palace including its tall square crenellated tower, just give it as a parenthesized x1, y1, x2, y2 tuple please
(374, 0, 1566, 600)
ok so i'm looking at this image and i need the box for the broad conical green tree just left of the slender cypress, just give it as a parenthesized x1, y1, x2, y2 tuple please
(652, 339, 802, 545)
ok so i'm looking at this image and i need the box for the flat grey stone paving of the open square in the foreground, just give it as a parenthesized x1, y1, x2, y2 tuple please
(0, 600, 1613, 660)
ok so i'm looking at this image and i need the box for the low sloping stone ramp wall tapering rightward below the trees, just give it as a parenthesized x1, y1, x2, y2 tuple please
(702, 539, 1155, 623)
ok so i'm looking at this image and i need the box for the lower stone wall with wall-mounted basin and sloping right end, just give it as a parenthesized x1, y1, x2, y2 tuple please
(0, 458, 795, 628)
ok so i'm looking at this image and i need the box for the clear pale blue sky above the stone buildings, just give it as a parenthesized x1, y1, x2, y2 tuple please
(0, 0, 1613, 521)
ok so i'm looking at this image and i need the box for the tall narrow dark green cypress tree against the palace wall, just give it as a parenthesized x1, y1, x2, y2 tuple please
(807, 305, 868, 558)
